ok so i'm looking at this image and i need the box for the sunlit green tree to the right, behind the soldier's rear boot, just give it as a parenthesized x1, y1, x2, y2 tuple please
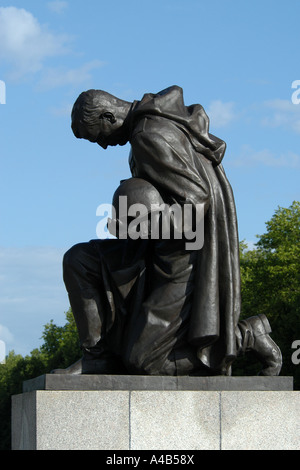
(234, 202, 300, 389)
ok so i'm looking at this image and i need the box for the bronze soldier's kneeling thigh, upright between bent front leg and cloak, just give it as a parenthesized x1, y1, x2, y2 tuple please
(124, 241, 201, 375)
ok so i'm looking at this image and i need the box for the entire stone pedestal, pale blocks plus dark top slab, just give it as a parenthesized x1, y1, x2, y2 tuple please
(12, 375, 300, 451)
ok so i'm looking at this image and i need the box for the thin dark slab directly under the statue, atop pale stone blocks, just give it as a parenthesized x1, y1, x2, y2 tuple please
(23, 374, 293, 393)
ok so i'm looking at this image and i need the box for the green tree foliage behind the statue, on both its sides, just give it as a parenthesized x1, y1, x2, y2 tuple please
(0, 202, 300, 450)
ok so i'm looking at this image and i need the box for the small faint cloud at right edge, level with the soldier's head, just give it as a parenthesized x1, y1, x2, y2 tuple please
(262, 99, 300, 134)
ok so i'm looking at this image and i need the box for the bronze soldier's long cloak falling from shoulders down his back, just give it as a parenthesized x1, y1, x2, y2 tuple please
(129, 86, 241, 374)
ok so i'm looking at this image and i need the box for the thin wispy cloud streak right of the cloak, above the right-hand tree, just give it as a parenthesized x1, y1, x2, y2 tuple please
(228, 145, 300, 169)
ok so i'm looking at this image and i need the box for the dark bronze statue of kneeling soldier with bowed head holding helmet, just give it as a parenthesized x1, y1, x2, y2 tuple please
(54, 86, 282, 376)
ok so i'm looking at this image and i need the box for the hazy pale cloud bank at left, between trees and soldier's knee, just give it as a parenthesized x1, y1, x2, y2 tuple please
(0, 247, 69, 355)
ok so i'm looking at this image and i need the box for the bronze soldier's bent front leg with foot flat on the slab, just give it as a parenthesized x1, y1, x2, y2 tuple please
(54, 240, 123, 374)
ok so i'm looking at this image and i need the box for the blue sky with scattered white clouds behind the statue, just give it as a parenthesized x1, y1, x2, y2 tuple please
(0, 0, 300, 355)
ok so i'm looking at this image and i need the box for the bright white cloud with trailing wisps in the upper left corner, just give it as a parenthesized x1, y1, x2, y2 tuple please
(0, 6, 103, 90)
